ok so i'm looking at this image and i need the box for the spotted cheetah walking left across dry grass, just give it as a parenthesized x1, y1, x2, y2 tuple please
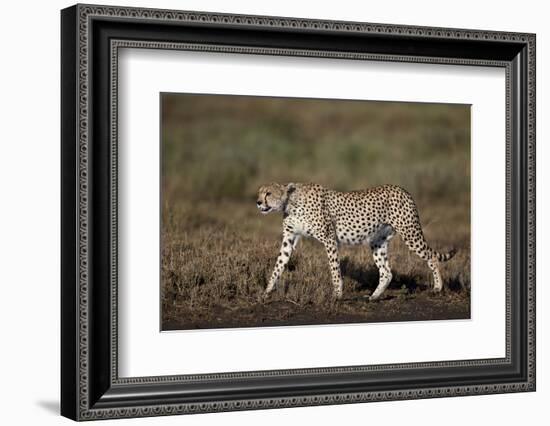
(256, 183, 456, 301)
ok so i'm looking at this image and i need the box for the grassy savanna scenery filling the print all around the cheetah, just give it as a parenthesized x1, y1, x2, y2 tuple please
(161, 94, 470, 330)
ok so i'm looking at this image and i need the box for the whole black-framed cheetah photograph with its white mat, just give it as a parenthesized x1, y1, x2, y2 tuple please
(61, 5, 535, 420)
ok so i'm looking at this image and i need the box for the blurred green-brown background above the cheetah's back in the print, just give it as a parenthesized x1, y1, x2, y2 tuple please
(162, 94, 470, 206)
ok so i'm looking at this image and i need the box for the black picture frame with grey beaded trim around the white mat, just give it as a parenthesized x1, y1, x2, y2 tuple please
(61, 5, 535, 420)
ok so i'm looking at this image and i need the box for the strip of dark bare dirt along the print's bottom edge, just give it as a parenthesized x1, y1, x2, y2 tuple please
(163, 289, 470, 330)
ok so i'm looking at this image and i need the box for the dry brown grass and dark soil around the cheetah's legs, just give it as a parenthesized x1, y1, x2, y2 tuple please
(162, 201, 470, 329)
